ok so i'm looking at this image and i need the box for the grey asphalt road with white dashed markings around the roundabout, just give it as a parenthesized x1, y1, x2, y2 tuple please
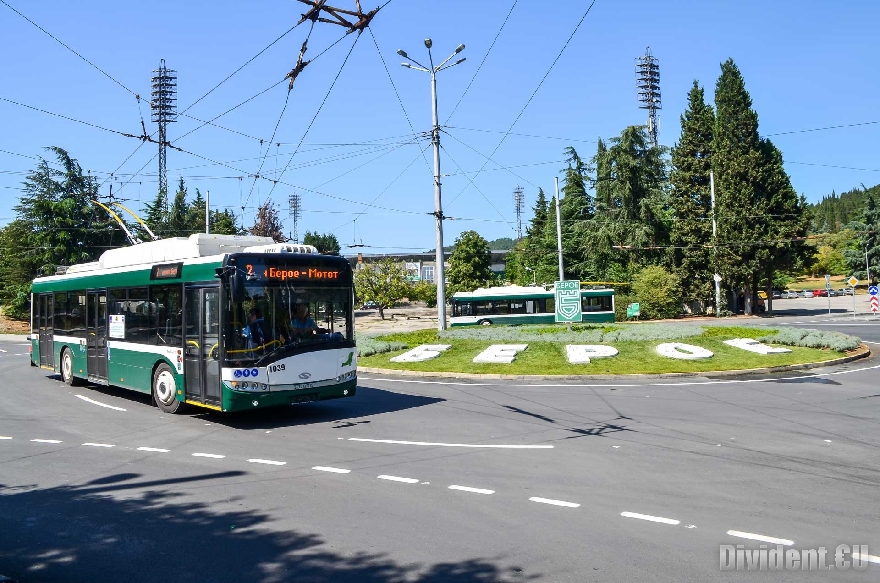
(0, 322, 880, 583)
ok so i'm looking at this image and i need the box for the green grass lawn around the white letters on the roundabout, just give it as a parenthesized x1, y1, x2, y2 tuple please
(358, 327, 842, 375)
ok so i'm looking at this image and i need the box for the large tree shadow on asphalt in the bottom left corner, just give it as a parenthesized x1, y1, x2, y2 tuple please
(0, 472, 539, 583)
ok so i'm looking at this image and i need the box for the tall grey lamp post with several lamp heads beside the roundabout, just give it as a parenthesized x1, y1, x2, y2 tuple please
(397, 38, 465, 330)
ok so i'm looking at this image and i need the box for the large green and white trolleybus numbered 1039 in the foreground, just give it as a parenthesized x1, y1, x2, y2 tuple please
(31, 234, 357, 413)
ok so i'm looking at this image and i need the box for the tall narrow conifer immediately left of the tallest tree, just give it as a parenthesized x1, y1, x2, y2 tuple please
(669, 81, 715, 301)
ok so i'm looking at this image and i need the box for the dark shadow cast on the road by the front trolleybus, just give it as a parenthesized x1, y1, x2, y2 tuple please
(196, 386, 445, 429)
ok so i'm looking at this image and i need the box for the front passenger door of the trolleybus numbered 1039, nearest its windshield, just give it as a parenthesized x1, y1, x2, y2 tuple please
(183, 287, 221, 405)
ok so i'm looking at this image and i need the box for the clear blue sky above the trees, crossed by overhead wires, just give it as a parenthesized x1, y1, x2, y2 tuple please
(0, 0, 880, 252)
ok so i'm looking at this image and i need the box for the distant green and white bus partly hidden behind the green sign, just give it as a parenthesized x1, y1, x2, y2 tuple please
(450, 285, 614, 326)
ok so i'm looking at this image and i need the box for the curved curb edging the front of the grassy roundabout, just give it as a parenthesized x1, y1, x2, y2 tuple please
(358, 344, 871, 381)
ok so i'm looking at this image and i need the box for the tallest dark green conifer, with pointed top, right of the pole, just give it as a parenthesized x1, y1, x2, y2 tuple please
(712, 59, 767, 314)
